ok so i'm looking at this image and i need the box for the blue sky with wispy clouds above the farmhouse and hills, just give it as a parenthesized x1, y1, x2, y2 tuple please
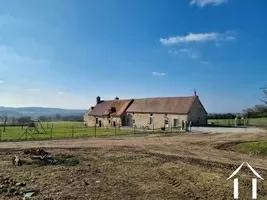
(0, 0, 267, 112)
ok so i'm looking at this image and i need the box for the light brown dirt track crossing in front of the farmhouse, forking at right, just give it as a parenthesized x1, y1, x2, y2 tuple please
(0, 132, 267, 169)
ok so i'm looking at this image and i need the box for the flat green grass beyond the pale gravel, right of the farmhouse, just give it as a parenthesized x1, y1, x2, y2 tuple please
(208, 118, 267, 126)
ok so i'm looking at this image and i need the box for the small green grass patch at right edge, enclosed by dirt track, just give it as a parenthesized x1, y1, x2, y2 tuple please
(235, 142, 267, 156)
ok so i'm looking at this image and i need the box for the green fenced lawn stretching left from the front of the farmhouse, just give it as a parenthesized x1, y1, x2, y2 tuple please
(0, 122, 136, 141)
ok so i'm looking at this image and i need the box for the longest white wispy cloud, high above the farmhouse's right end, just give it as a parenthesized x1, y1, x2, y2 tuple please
(159, 31, 236, 45)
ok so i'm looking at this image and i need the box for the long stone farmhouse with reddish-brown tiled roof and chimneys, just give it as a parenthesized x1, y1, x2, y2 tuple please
(84, 95, 207, 129)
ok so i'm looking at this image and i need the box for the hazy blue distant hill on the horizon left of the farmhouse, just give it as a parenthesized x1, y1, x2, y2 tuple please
(0, 106, 87, 117)
